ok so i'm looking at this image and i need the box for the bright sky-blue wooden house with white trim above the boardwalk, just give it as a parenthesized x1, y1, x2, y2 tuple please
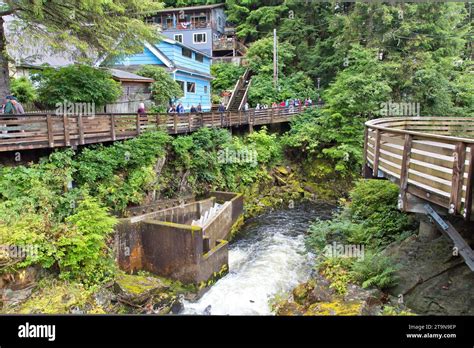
(114, 38, 212, 111)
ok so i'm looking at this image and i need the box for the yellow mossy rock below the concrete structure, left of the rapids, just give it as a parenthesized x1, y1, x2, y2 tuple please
(114, 274, 169, 305)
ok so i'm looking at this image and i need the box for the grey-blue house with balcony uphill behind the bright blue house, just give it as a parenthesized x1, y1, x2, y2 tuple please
(147, 4, 246, 59)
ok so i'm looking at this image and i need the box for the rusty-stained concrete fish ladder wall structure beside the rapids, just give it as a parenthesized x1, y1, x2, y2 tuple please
(115, 192, 243, 283)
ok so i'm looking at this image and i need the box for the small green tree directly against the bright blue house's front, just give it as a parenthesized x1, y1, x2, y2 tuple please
(137, 65, 184, 107)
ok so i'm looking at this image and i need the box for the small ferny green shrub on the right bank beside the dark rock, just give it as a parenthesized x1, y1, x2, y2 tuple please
(351, 252, 397, 289)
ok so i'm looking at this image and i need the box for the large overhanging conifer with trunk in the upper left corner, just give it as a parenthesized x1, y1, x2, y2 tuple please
(0, 0, 162, 95)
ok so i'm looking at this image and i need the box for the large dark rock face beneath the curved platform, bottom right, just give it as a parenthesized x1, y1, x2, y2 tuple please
(386, 227, 474, 315)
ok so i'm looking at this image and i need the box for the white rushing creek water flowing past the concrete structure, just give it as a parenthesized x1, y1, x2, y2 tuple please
(183, 204, 333, 315)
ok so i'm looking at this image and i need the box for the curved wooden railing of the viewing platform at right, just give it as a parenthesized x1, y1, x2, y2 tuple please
(364, 117, 474, 220)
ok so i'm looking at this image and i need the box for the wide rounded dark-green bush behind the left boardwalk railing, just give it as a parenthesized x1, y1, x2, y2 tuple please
(35, 65, 122, 106)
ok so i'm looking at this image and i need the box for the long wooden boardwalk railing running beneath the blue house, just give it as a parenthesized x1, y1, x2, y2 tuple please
(0, 107, 312, 152)
